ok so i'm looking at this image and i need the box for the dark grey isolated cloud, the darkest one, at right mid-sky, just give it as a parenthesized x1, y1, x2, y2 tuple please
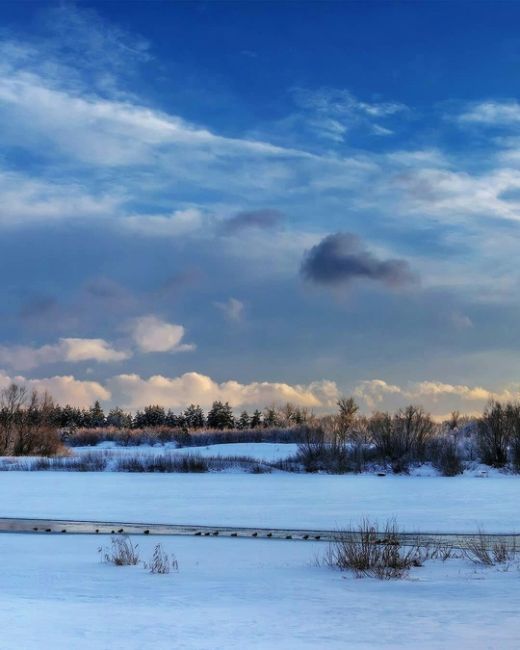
(300, 232, 414, 287)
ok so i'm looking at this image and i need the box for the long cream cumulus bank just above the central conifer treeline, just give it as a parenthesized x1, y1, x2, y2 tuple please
(108, 372, 339, 409)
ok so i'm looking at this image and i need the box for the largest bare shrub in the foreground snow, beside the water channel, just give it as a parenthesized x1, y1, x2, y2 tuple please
(325, 519, 425, 580)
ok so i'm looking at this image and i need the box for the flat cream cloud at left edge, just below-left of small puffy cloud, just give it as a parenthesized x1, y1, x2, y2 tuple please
(0, 338, 132, 370)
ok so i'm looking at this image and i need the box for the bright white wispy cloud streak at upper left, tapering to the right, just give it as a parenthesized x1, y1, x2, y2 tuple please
(0, 61, 290, 167)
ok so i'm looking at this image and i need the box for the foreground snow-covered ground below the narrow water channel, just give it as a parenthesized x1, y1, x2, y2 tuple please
(0, 532, 520, 650)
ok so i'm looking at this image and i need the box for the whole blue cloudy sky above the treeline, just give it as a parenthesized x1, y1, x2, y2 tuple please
(0, 0, 520, 417)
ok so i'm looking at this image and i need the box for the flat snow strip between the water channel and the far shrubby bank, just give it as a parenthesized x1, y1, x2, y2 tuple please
(0, 471, 520, 532)
